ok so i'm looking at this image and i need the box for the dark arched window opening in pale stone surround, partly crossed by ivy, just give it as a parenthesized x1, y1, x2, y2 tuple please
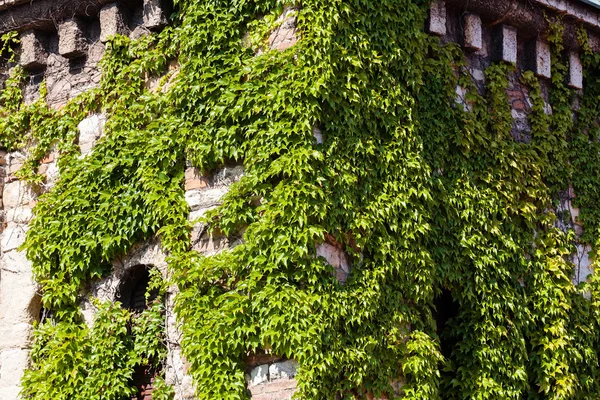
(117, 265, 158, 400)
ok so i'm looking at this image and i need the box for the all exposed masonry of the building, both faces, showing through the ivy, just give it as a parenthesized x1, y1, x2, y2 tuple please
(0, 0, 600, 400)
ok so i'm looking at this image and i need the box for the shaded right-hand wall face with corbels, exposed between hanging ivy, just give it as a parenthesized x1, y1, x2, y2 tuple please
(426, 0, 600, 283)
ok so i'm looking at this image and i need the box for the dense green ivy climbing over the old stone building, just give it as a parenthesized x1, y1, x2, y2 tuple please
(0, 0, 600, 399)
